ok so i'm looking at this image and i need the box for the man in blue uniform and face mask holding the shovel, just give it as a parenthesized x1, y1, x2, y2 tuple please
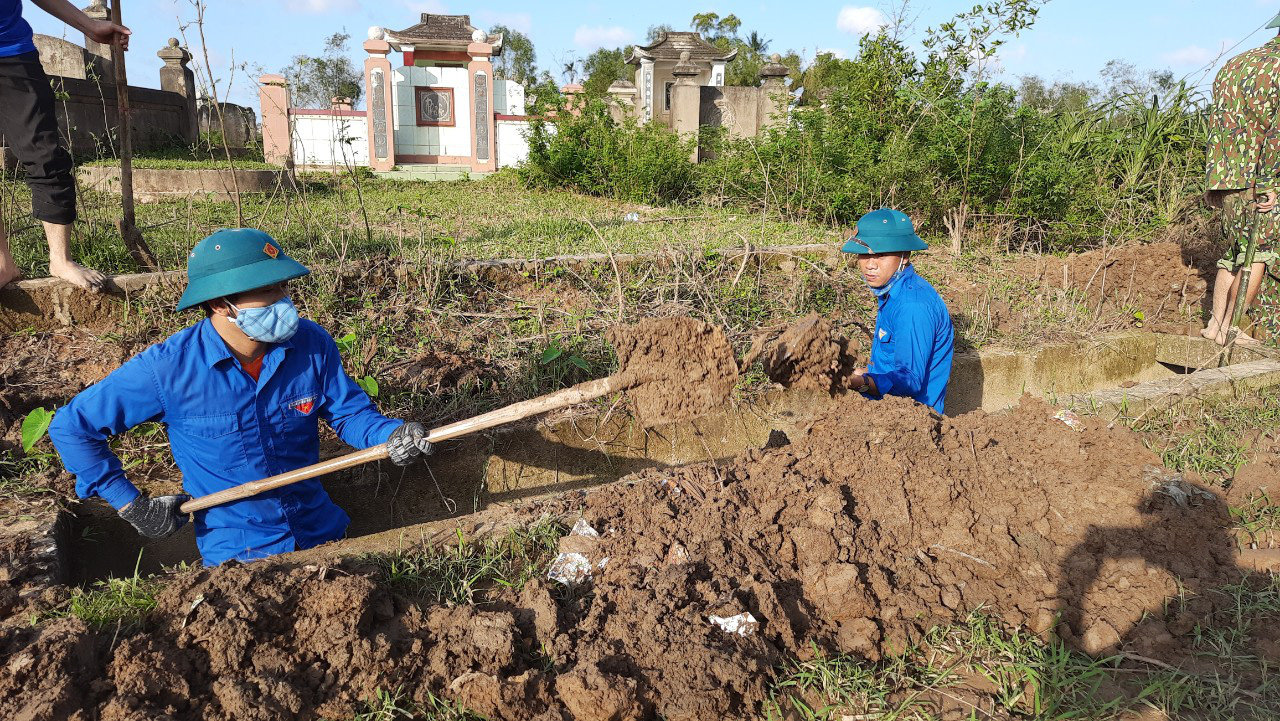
(49, 228, 431, 566)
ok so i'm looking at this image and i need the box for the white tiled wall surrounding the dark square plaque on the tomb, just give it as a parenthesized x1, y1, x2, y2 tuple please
(392, 67, 474, 163)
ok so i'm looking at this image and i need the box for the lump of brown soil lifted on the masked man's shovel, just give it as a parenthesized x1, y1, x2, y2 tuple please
(605, 318, 737, 426)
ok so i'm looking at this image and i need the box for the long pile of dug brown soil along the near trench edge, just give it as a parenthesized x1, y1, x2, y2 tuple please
(0, 396, 1271, 720)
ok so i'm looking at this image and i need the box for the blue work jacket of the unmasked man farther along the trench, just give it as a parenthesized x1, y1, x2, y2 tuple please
(867, 265, 956, 414)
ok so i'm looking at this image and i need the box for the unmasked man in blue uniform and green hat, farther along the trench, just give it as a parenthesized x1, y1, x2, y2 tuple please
(840, 207, 955, 414)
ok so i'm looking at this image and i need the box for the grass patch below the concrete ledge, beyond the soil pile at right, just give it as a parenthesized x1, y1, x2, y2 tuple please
(1129, 387, 1280, 483)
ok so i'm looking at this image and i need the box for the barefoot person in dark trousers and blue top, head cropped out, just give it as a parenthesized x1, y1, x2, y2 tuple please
(0, 0, 129, 291)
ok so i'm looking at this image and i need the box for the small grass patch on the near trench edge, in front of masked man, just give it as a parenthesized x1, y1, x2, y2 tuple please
(366, 523, 564, 604)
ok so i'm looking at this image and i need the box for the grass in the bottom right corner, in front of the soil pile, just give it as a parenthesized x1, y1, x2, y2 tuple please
(764, 591, 1280, 721)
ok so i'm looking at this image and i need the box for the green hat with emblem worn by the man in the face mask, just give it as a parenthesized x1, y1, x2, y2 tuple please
(178, 228, 311, 310)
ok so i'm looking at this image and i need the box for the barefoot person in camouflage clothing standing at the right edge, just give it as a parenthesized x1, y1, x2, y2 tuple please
(1201, 15, 1280, 344)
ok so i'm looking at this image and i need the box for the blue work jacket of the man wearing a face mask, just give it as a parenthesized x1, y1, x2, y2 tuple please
(49, 319, 402, 566)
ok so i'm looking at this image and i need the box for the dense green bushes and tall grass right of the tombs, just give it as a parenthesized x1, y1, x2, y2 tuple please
(522, 0, 1207, 250)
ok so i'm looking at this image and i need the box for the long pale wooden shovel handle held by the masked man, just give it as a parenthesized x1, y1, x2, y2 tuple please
(179, 373, 640, 514)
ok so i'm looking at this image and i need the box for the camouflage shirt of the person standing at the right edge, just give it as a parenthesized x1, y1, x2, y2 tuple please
(1206, 37, 1280, 191)
